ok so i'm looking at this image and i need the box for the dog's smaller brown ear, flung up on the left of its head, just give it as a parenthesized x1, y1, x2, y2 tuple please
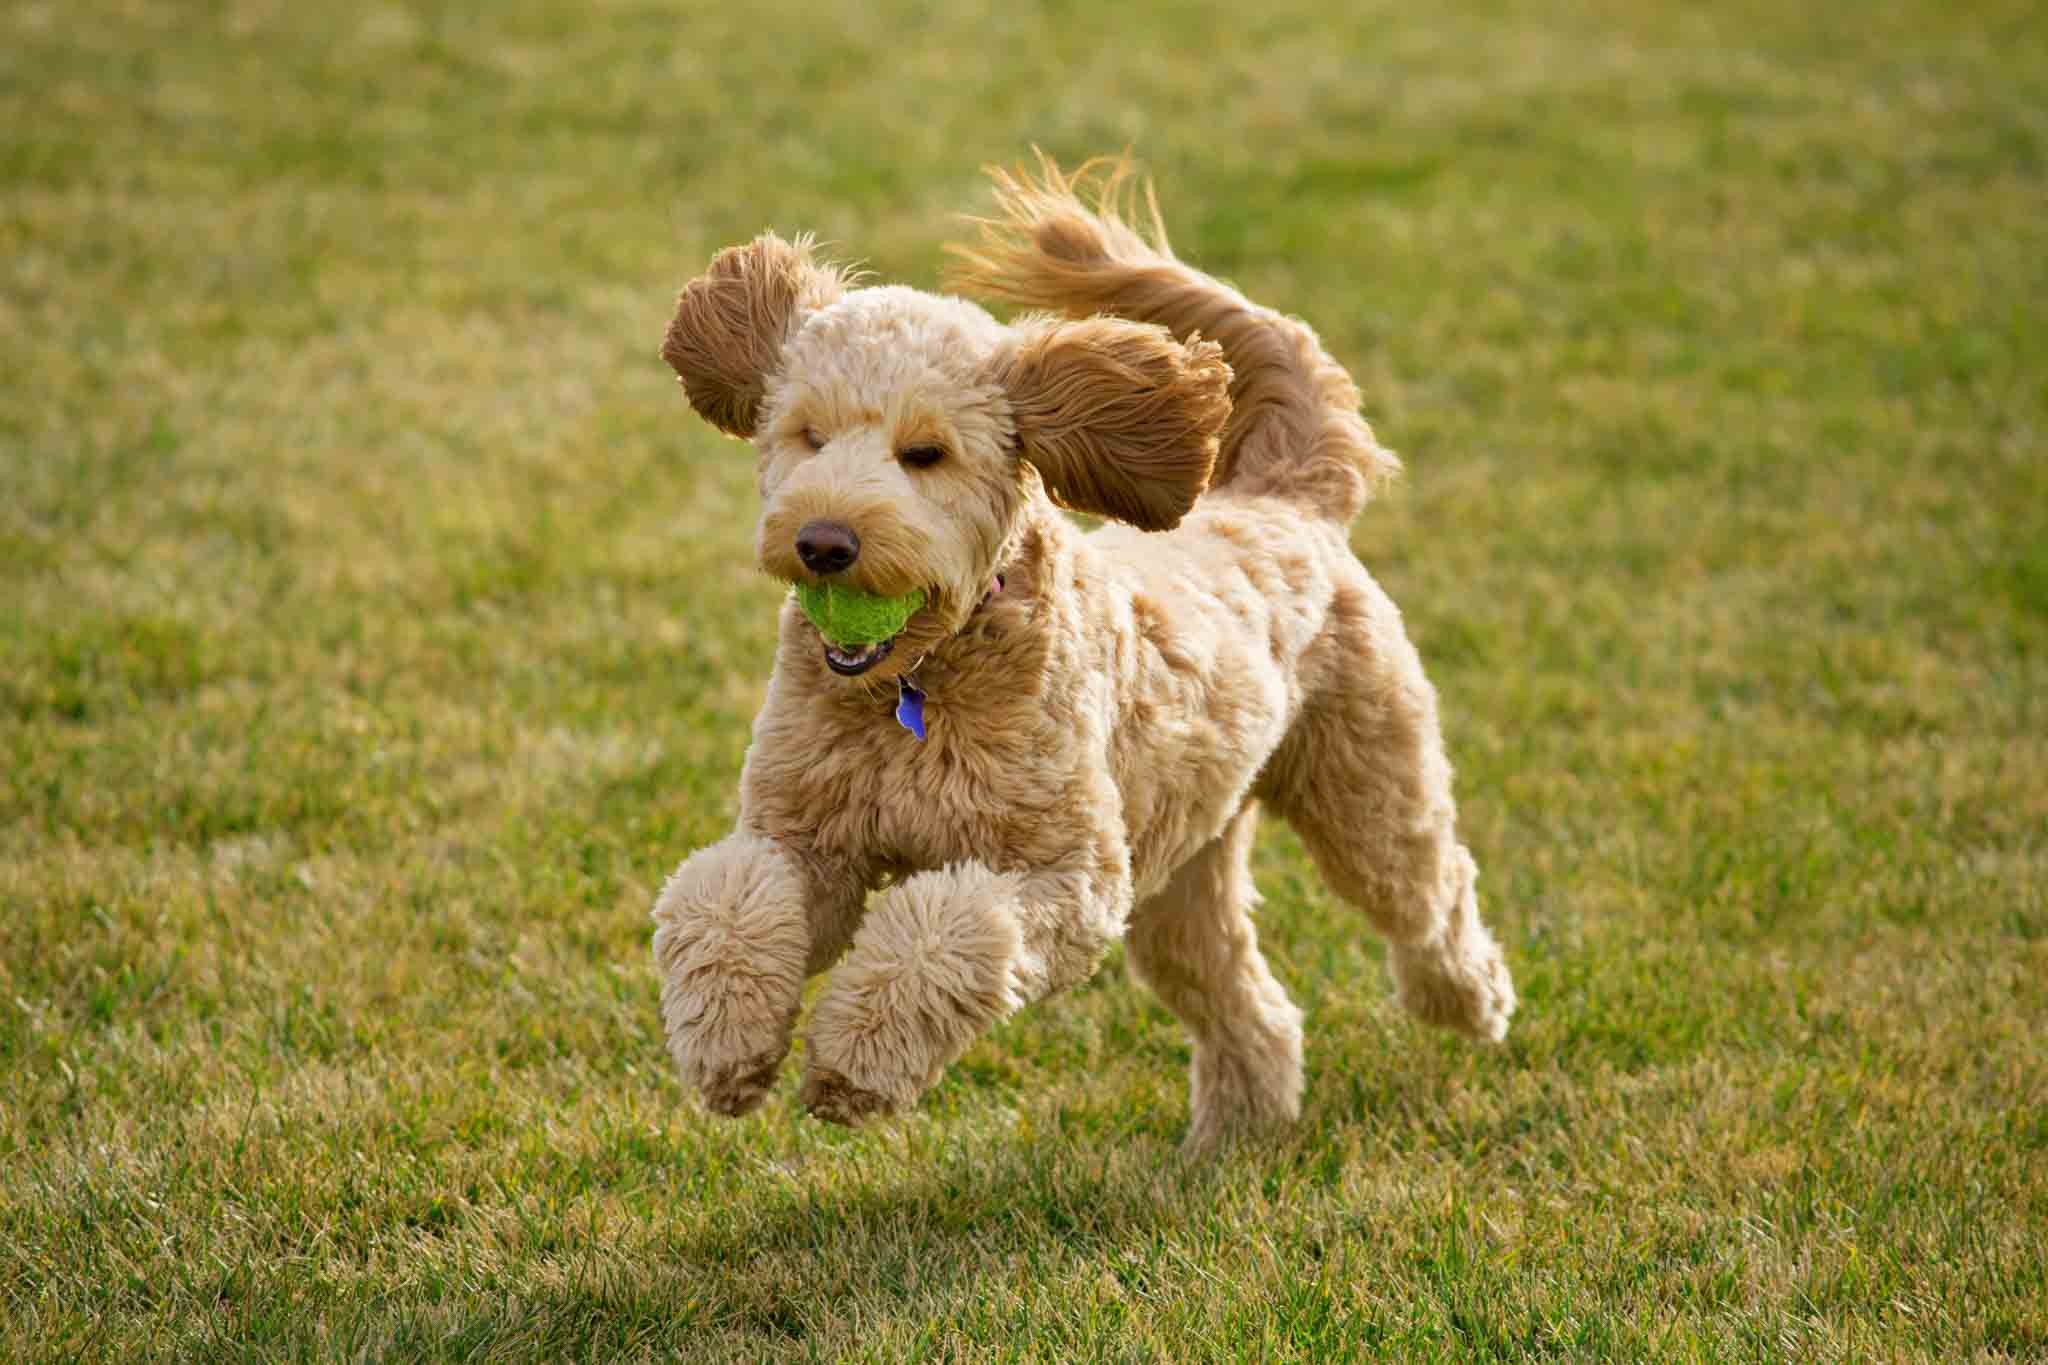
(662, 233, 846, 436)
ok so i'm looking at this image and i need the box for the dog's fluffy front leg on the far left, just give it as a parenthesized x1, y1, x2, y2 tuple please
(653, 833, 862, 1115)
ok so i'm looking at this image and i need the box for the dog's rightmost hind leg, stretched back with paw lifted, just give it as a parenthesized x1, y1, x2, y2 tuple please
(1257, 571, 1516, 1042)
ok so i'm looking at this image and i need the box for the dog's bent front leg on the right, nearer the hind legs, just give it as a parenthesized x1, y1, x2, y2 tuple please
(801, 862, 1128, 1124)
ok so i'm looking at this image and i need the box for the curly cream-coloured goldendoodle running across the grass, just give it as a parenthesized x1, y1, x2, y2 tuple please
(653, 162, 1516, 1152)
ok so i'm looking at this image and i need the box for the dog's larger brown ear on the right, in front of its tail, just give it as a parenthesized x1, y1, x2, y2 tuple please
(993, 317, 1231, 530)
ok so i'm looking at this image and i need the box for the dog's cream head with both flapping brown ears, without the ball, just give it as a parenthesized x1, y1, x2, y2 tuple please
(662, 235, 1231, 675)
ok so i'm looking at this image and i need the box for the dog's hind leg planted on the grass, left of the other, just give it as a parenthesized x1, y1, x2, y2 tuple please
(1124, 802, 1300, 1156)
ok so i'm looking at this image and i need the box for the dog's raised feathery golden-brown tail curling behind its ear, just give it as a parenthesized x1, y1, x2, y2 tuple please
(946, 153, 1401, 522)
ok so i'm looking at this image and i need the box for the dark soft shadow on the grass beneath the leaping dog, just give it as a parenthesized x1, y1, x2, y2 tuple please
(442, 1130, 1220, 1359)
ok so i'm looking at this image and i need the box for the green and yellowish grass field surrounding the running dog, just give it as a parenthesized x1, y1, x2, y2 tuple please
(0, 0, 2048, 1361)
